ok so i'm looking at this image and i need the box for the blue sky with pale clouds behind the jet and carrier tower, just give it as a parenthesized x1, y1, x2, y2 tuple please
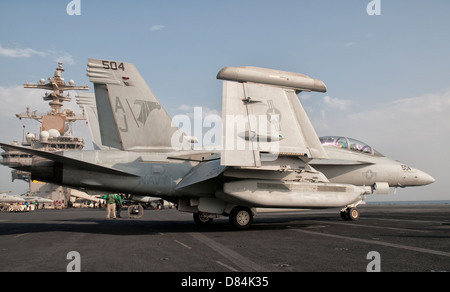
(0, 0, 450, 200)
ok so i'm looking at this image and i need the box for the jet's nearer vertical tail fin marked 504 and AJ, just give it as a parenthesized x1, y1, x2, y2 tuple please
(87, 59, 190, 151)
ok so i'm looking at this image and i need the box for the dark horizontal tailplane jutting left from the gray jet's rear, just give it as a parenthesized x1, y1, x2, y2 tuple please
(0, 143, 137, 177)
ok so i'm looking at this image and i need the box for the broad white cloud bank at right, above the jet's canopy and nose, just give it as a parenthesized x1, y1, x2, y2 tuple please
(312, 90, 450, 144)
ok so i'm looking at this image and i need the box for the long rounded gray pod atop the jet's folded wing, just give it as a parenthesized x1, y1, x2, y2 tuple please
(217, 66, 327, 92)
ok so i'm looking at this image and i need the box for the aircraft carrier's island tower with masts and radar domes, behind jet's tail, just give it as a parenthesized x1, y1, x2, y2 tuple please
(1, 63, 89, 205)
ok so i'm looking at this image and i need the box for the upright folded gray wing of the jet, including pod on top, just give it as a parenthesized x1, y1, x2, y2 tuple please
(217, 67, 328, 167)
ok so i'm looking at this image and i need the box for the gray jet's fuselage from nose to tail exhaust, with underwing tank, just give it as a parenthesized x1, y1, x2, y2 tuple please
(25, 136, 434, 210)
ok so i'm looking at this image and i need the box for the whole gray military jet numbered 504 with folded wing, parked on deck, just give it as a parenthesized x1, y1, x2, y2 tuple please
(0, 59, 434, 229)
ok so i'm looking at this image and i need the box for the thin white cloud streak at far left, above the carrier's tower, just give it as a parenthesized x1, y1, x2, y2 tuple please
(0, 44, 75, 65)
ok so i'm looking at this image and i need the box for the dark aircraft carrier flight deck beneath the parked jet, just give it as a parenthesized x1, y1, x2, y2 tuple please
(0, 204, 450, 272)
